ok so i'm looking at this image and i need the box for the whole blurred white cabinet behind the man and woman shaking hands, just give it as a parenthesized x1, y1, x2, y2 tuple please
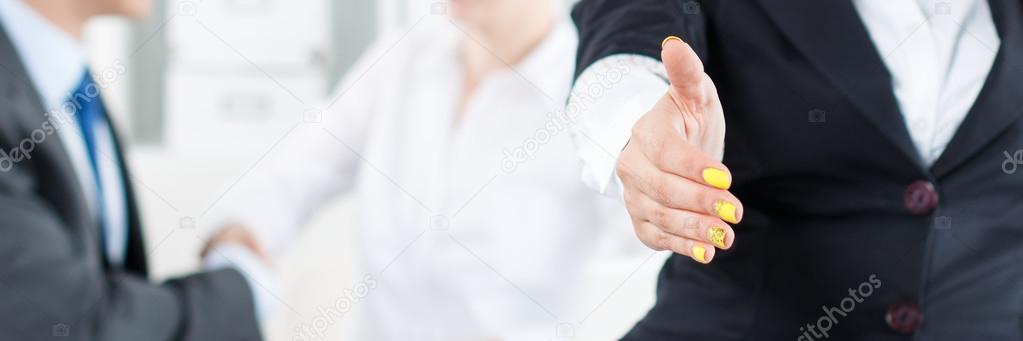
(129, 0, 379, 155)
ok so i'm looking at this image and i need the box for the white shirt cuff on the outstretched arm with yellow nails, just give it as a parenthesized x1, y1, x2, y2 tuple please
(566, 54, 668, 201)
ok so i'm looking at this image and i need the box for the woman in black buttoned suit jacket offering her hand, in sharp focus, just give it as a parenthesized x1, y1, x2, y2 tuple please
(574, 0, 1023, 341)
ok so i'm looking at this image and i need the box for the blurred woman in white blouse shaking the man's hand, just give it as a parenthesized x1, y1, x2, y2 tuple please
(203, 0, 641, 341)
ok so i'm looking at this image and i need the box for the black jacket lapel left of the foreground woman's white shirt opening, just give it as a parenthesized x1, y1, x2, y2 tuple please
(759, 0, 925, 172)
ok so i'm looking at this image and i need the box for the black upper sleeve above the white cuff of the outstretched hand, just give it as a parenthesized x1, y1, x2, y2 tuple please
(572, 0, 707, 78)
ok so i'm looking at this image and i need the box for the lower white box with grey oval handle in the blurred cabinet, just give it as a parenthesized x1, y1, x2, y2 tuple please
(164, 71, 323, 151)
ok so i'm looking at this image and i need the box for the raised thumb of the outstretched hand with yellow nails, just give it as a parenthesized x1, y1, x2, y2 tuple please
(661, 36, 704, 99)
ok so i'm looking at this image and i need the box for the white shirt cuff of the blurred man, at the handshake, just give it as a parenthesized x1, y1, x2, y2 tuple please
(203, 244, 277, 323)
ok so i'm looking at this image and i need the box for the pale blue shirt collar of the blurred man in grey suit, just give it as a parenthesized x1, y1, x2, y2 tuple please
(0, 0, 86, 111)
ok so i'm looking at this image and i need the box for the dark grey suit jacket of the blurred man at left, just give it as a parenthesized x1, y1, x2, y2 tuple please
(0, 24, 261, 341)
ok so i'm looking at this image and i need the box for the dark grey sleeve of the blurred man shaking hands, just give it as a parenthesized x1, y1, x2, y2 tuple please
(0, 174, 261, 341)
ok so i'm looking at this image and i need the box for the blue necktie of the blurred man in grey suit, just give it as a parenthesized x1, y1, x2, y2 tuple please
(71, 71, 118, 261)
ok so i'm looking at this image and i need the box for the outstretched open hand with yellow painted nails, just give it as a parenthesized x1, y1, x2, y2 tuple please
(617, 37, 743, 263)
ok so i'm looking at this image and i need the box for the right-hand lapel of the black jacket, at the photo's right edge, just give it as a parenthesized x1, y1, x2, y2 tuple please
(932, 0, 1023, 177)
